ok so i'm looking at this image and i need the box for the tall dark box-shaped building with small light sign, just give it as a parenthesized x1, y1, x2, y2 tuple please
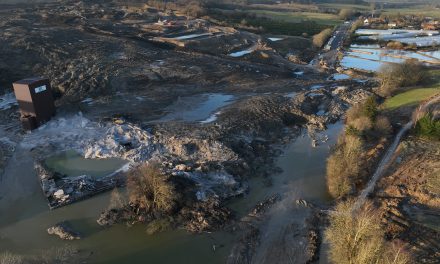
(13, 78, 55, 130)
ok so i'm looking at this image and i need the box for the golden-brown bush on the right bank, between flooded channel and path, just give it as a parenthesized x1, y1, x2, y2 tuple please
(326, 135, 364, 198)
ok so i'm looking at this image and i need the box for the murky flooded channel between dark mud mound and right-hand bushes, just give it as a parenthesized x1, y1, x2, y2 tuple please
(229, 123, 342, 214)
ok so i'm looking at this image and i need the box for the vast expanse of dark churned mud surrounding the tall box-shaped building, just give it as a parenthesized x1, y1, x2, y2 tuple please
(0, 1, 378, 262)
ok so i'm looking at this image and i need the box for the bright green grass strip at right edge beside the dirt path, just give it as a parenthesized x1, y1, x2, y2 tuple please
(383, 87, 440, 110)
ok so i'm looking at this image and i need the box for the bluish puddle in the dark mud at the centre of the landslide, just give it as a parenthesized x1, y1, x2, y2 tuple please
(158, 94, 234, 123)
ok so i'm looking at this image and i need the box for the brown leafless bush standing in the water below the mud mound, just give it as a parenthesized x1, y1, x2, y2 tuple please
(127, 164, 176, 213)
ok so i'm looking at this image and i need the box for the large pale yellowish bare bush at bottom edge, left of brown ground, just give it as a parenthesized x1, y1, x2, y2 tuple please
(325, 200, 410, 264)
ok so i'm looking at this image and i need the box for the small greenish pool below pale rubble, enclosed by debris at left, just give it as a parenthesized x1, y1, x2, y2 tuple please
(45, 150, 127, 177)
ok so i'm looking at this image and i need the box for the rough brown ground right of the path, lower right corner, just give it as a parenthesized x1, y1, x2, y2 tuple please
(373, 136, 440, 263)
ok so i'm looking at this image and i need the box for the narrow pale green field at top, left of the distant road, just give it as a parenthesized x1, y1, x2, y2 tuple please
(248, 10, 341, 26)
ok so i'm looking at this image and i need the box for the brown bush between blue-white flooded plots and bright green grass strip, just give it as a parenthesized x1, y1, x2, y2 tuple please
(377, 60, 428, 96)
